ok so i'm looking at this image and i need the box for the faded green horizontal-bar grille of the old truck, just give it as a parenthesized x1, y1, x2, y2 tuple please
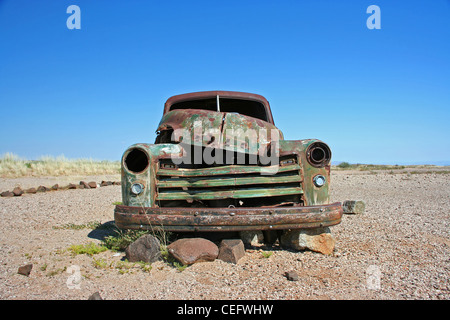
(155, 158, 303, 203)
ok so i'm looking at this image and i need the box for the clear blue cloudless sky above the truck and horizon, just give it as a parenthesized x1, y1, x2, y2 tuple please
(0, 0, 450, 164)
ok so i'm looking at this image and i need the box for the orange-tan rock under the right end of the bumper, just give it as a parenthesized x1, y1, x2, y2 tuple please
(281, 227, 336, 254)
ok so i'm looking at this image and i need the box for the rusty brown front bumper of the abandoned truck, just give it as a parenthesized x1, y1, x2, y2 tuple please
(114, 202, 343, 232)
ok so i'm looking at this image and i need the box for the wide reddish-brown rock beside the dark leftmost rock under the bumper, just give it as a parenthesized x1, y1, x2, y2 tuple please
(167, 238, 219, 265)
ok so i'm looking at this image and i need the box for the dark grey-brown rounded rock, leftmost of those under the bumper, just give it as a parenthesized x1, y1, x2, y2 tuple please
(125, 234, 161, 263)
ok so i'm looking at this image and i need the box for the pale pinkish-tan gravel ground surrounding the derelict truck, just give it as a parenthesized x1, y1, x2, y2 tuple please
(0, 171, 450, 300)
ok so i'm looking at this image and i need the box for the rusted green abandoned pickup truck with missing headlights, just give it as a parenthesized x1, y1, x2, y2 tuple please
(114, 91, 342, 232)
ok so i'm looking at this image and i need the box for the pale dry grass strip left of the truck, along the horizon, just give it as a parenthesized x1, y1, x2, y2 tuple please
(0, 153, 120, 178)
